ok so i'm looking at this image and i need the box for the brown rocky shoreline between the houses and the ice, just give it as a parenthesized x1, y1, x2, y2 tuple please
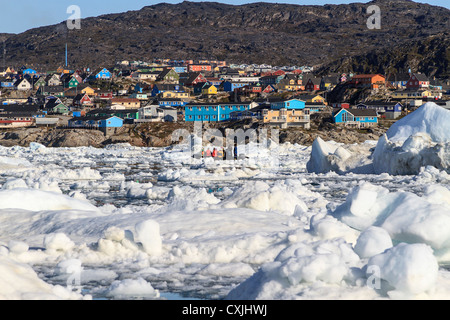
(0, 119, 387, 148)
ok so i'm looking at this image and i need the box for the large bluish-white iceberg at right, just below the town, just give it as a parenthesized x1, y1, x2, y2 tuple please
(307, 102, 450, 175)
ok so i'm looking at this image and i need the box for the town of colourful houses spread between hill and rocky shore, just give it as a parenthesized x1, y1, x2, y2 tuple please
(0, 59, 450, 130)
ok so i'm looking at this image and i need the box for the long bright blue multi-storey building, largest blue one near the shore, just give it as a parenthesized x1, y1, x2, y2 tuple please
(184, 103, 250, 122)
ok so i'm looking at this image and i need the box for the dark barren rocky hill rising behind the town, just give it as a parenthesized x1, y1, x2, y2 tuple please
(0, 0, 450, 77)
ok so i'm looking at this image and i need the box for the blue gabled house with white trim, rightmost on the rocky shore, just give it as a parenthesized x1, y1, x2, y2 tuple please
(333, 108, 378, 128)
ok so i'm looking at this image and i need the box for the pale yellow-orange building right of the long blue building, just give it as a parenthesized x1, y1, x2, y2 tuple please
(263, 108, 310, 129)
